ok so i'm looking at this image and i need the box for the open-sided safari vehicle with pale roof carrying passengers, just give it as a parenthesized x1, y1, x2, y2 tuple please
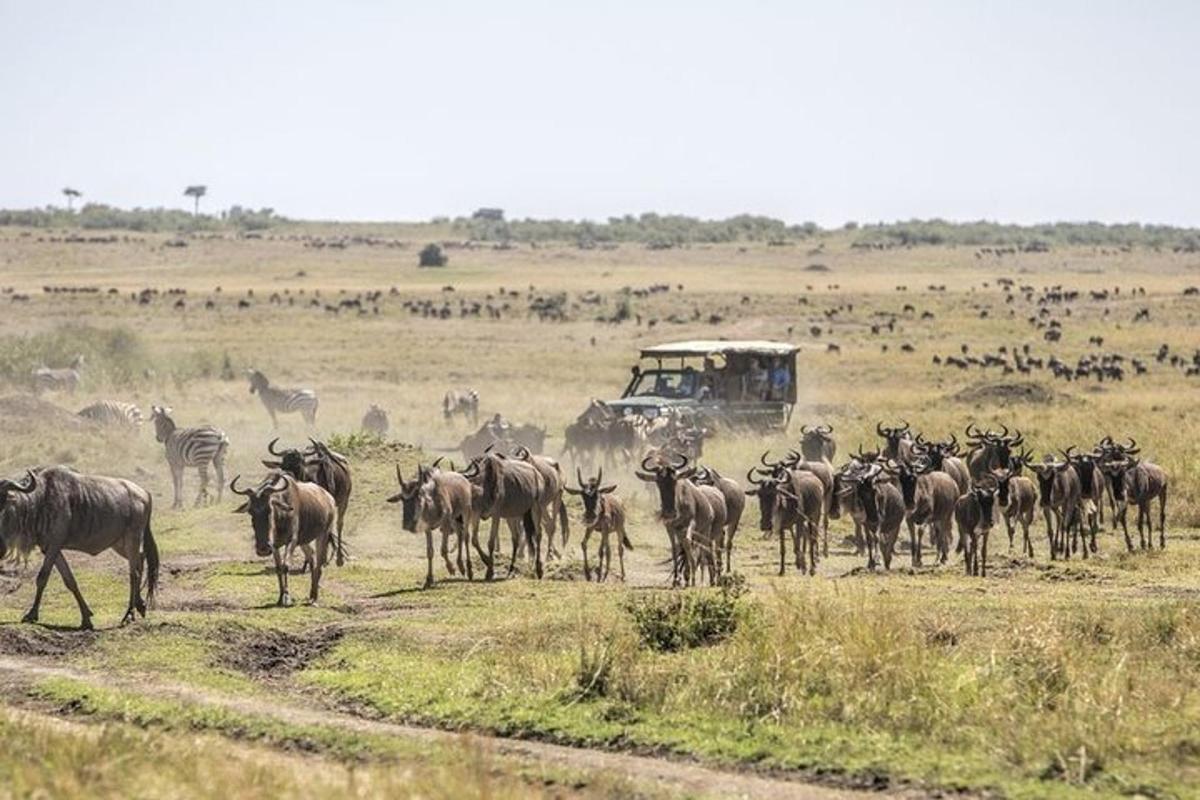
(608, 339, 799, 429)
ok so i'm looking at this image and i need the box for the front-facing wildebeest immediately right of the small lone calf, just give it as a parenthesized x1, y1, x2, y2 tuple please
(636, 456, 725, 585)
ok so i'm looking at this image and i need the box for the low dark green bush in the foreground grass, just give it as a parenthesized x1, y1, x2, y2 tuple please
(624, 578, 745, 652)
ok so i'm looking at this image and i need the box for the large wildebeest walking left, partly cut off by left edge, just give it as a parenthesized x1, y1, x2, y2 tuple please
(0, 467, 158, 630)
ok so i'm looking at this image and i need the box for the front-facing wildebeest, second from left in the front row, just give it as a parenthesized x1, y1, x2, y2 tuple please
(229, 471, 337, 606)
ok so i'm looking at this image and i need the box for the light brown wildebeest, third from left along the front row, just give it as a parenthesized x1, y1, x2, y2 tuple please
(388, 462, 477, 589)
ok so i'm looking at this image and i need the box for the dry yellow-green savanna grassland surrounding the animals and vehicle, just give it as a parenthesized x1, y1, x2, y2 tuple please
(0, 224, 1200, 798)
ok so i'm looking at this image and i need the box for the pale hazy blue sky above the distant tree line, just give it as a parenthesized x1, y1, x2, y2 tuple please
(0, 0, 1200, 225)
